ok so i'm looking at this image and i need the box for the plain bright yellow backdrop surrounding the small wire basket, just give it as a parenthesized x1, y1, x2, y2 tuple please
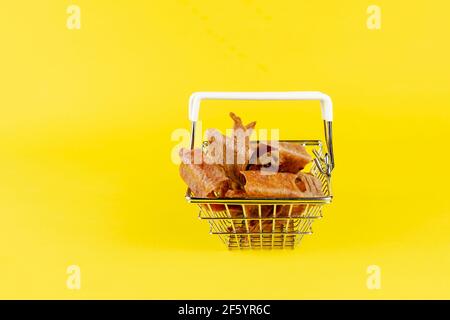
(0, 0, 450, 299)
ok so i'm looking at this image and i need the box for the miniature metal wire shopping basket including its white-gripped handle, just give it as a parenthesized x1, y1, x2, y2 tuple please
(186, 91, 334, 249)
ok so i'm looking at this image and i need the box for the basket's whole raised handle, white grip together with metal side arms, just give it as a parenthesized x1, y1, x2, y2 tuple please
(189, 91, 334, 175)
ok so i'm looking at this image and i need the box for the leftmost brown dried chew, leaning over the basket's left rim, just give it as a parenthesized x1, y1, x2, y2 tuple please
(180, 149, 229, 198)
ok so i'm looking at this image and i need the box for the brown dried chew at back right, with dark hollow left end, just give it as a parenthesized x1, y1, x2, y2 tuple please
(249, 142, 312, 173)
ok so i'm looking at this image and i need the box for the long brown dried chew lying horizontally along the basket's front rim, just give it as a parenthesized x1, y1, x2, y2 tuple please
(242, 171, 303, 198)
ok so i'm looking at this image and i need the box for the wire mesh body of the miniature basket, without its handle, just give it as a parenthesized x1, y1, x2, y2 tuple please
(186, 140, 332, 249)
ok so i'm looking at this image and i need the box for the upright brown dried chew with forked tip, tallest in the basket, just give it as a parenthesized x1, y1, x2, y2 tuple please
(206, 112, 256, 189)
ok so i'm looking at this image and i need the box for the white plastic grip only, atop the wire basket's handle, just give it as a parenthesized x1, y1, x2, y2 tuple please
(189, 91, 333, 122)
